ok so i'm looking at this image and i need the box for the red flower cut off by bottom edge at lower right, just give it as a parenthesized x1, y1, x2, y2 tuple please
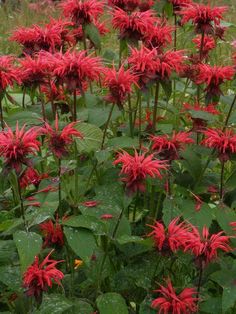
(151, 279, 198, 314)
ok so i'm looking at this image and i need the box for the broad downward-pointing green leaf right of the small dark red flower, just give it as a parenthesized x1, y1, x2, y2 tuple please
(64, 227, 97, 262)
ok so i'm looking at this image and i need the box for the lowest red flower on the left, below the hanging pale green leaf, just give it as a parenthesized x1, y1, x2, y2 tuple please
(23, 251, 64, 300)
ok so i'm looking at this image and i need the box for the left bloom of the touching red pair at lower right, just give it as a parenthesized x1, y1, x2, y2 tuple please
(148, 217, 189, 255)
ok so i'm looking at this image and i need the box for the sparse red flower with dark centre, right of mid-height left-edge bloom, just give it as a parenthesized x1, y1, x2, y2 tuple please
(40, 115, 83, 159)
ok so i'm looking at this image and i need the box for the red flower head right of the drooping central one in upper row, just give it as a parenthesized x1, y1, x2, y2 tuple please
(128, 46, 157, 87)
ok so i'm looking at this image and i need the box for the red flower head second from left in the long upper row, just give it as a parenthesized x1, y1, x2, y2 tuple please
(19, 53, 52, 88)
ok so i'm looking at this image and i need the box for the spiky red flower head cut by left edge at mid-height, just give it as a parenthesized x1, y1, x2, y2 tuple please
(0, 122, 40, 172)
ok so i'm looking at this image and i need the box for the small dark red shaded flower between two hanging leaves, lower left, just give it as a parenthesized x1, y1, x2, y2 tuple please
(39, 219, 64, 248)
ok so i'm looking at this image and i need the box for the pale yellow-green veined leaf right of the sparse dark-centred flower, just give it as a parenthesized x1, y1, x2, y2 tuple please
(76, 123, 103, 153)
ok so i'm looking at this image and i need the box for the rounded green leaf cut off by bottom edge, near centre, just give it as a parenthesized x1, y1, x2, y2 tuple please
(96, 292, 128, 314)
